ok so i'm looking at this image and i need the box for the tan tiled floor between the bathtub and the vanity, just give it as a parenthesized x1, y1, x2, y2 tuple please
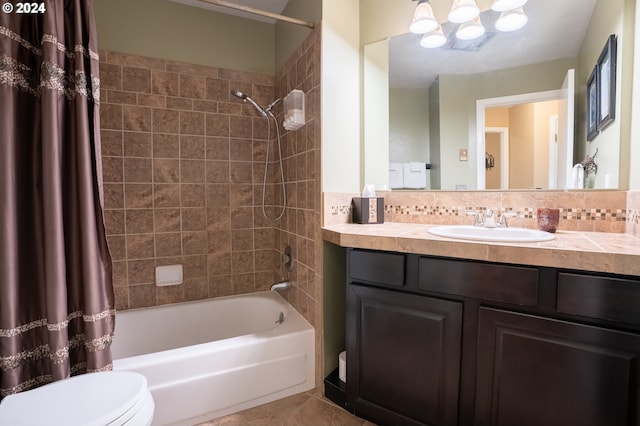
(198, 392, 375, 426)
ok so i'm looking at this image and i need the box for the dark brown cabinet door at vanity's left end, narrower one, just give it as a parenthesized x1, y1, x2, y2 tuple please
(347, 284, 462, 425)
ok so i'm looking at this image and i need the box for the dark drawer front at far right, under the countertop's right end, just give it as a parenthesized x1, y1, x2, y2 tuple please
(558, 272, 640, 325)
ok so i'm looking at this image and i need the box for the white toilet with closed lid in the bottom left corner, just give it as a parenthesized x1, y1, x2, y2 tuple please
(0, 371, 154, 426)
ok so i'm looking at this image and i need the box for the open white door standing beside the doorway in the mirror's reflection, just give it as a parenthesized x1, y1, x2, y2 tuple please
(556, 69, 576, 189)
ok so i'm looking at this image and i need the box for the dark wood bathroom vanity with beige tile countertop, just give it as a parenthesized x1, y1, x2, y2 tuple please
(325, 224, 640, 426)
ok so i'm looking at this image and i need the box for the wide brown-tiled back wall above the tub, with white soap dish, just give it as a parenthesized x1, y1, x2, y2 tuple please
(100, 51, 277, 309)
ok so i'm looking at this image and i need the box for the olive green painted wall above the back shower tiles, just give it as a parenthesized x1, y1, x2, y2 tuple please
(94, 0, 274, 75)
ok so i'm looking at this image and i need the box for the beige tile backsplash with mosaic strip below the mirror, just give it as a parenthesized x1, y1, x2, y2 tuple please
(324, 191, 640, 233)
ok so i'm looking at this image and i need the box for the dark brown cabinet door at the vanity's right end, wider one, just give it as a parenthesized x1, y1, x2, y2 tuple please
(475, 308, 640, 426)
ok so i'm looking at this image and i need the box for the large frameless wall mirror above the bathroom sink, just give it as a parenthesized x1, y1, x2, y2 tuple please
(363, 0, 635, 190)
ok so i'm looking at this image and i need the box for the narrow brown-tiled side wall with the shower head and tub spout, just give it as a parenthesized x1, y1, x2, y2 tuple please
(275, 28, 323, 389)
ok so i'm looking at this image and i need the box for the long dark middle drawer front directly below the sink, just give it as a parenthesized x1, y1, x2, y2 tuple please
(418, 257, 538, 306)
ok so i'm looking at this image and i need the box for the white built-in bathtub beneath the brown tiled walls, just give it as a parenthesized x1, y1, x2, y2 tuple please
(112, 291, 315, 425)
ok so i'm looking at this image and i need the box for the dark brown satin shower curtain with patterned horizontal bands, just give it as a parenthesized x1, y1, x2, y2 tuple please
(0, 0, 115, 399)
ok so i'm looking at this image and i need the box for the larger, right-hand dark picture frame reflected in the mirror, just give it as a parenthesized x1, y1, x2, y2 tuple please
(596, 34, 617, 130)
